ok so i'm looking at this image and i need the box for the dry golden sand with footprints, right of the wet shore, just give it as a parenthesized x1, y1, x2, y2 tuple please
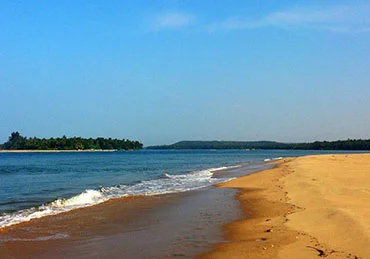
(201, 154, 370, 259)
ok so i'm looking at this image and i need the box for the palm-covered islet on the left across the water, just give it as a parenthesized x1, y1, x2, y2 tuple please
(0, 132, 143, 150)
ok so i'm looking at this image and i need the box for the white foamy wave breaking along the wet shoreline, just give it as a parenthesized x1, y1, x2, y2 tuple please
(0, 166, 238, 229)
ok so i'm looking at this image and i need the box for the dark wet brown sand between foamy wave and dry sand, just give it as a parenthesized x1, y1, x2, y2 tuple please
(0, 164, 266, 259)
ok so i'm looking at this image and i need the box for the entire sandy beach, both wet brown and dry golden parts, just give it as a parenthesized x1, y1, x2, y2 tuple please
(0, 154, 370, 259)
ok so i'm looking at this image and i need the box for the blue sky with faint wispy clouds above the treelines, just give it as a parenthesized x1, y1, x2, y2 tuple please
(0, 0, 370, 145)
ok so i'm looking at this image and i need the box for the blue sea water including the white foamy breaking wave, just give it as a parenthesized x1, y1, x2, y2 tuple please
(0, 150, 358, 228)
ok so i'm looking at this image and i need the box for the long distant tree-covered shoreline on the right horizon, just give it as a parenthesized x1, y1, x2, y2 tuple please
(147, 139, 370, 150)
